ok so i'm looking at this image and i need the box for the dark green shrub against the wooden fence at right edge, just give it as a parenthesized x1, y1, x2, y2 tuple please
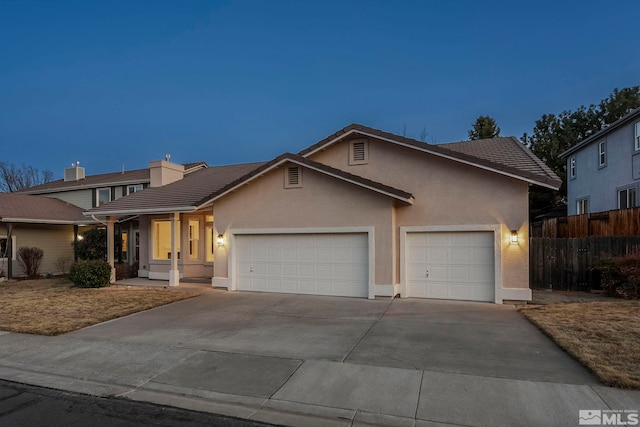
(596, 254, 640, 299)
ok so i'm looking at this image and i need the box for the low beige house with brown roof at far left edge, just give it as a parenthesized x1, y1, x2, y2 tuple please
(0, 193, 96, 278)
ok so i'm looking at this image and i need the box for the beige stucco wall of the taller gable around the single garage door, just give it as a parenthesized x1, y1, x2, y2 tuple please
(310, 138, 529, 288)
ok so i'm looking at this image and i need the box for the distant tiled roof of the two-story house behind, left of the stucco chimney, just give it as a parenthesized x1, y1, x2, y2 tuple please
(20, 169, 150, 194)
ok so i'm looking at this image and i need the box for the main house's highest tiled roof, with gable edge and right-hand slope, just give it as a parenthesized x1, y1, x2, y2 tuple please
(299, 124, 562, 189)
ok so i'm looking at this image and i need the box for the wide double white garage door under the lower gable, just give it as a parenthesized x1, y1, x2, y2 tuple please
(236, 233, 369, 298)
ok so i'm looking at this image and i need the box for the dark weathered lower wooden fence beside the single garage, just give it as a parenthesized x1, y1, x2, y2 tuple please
(529, 236, 640, 291)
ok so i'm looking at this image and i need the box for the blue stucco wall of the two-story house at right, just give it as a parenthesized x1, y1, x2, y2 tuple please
(567, 123, 640, 215)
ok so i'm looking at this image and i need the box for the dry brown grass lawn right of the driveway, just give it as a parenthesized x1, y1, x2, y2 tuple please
(521, 300, 640, 389)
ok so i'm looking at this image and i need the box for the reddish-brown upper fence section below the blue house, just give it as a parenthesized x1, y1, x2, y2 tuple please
(531, 207, 640, 239)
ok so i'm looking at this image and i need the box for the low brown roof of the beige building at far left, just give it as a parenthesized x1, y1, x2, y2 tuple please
(0, 193, 93, 224)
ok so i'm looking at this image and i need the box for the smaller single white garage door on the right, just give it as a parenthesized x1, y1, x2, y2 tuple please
(406, 231, 495, 301)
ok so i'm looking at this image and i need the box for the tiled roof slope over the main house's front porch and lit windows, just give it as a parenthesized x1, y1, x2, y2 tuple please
(88, 163, 263, 215)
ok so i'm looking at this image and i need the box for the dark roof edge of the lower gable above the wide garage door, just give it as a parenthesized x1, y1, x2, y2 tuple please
(198, 153, 413, 207)
